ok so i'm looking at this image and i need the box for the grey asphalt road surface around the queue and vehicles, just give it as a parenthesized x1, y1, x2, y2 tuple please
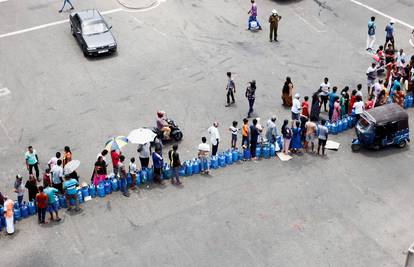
(0, 0, 414, 267)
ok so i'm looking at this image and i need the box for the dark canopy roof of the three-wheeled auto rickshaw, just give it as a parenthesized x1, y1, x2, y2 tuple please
(362, 103, 408, 125)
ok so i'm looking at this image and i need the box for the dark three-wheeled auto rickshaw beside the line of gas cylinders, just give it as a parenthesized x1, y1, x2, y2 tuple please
(351, 103, 410, 152)
